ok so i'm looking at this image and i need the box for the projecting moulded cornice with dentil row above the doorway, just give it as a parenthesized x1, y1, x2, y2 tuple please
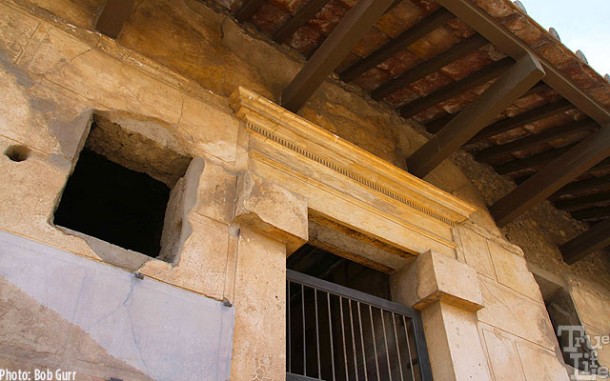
(231, 87, 475, 226)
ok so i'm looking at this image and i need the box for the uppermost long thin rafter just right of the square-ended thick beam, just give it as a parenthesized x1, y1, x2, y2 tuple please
(470, 99, 574, 143)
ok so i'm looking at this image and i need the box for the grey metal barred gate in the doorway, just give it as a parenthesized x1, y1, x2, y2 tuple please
(286, 270, 432, 381)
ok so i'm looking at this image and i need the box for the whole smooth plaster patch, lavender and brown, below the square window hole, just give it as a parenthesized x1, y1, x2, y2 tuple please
(0, 232, 235, 381)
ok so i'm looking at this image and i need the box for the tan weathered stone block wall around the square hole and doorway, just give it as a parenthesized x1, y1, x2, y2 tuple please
(0, 0, 610, 381)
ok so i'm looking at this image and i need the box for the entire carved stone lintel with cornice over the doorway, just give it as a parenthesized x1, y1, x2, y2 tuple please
(231, 87, 475, 262)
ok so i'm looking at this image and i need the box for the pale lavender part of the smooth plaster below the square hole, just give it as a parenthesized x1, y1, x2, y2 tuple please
(0, 233, 234, 380)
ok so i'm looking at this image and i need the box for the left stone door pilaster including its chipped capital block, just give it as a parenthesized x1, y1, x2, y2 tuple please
(231, 172, 308, 380)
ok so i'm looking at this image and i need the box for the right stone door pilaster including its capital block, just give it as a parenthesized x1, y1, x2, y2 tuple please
(391, 251, 491, 381)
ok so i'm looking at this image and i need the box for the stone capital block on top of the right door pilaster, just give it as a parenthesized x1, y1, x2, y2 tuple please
(391, 251, 483, 312)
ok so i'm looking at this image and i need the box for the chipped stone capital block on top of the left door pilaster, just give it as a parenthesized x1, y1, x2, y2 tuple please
(235, 172, 309, 255)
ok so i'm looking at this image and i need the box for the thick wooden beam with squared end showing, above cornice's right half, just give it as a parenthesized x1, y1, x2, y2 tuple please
(407, 55, 544, 178)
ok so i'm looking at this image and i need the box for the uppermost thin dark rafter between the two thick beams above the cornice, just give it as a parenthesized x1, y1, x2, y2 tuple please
(340, 8, 455, 82)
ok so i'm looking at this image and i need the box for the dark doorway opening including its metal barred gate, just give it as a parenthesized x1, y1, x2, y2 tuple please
(286, 245, 427, 381)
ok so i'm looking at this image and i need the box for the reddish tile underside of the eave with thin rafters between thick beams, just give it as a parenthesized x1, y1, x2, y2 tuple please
(216, 0, 610, 252)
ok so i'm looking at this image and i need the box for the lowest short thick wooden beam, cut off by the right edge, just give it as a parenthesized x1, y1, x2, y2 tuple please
(559, 220, 610, 265)
